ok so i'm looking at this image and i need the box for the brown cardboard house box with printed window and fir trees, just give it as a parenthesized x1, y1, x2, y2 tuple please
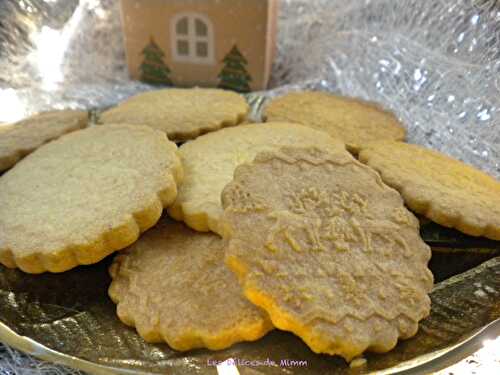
(121, 0, 278, 92)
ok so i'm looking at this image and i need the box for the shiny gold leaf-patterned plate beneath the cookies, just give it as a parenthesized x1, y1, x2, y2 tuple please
(0, 96, 500, 375)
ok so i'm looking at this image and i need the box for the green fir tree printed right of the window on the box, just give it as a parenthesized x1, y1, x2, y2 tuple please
(218, 45, 252, 92)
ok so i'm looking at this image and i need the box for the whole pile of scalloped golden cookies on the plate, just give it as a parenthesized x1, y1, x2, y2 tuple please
(0, 89, 500, 361)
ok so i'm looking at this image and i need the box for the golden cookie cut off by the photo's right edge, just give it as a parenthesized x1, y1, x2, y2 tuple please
(359, 142, 500, 240)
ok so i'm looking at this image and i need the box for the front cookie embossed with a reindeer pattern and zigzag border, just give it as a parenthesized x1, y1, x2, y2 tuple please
(222, 148, 433, 361)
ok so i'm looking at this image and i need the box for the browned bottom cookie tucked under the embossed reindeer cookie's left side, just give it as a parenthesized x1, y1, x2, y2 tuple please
(109, 218, 273, 351)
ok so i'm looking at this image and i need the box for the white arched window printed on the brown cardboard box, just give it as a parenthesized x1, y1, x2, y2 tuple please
(171, 13, 214, 64)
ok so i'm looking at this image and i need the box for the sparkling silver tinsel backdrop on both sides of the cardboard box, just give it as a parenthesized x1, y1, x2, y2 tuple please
(0, 0, 500, 177)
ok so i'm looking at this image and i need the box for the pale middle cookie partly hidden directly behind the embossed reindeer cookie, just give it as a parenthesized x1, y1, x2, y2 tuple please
(168, 123, 345, 234)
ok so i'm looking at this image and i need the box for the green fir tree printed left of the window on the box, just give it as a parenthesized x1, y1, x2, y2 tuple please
(140, 37, 172, 85)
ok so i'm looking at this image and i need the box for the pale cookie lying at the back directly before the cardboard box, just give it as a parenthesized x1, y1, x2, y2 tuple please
(99, 89, 249, 142)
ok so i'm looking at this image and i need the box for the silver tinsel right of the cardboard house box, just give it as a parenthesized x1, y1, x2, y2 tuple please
(275, 0, 500, 178)
